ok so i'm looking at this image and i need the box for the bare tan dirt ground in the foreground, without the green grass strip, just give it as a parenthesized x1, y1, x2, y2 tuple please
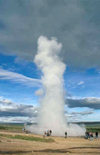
(0, 132, 100, 155)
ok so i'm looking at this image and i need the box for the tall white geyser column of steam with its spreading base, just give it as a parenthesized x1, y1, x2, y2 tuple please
(27, 36, 85, 136)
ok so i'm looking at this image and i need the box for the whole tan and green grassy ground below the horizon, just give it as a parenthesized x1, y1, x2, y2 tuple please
(0, 124, 100, 155)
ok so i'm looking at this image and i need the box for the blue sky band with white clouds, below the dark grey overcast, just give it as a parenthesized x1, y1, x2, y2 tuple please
(0, 54, 100, 122)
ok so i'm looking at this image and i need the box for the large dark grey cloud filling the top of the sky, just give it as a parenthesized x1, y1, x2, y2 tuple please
(0, 0, 100, 68)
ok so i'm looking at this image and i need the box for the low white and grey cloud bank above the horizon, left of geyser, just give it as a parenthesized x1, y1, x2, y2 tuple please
(0, 98, 38, 123)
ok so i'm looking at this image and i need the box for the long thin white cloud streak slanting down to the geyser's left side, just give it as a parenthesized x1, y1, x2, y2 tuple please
(0, 69, 41, 87)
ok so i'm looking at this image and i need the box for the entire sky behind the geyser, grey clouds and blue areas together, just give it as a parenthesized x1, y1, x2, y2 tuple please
(0, 0, 100, 122)
